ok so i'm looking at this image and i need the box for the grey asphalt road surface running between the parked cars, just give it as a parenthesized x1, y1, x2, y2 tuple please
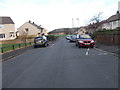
(2, 38, 118, 88)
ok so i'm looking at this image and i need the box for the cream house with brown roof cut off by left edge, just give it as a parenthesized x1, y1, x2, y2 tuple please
(0, 16, 16, 41)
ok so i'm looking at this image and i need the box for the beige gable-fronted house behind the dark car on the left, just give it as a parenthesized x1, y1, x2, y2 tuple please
(18, 21, 46, 37)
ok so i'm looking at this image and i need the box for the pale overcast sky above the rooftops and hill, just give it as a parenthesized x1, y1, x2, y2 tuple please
(0, 0, 119, 31)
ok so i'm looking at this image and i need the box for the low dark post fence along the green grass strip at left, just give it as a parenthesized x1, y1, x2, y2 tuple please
(0, 42, 33, 53)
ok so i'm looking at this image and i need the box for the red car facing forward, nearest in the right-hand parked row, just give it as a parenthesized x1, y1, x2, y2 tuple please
(76, 34, 94, 48)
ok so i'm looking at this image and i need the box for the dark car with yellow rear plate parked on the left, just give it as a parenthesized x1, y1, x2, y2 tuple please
(34, 36, 49, 48)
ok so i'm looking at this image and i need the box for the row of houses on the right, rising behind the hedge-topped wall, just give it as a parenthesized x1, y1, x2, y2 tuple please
(86, 11, 120, 34)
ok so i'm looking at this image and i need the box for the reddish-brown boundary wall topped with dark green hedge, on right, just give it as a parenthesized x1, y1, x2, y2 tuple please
(93, 30, 120, 45)
